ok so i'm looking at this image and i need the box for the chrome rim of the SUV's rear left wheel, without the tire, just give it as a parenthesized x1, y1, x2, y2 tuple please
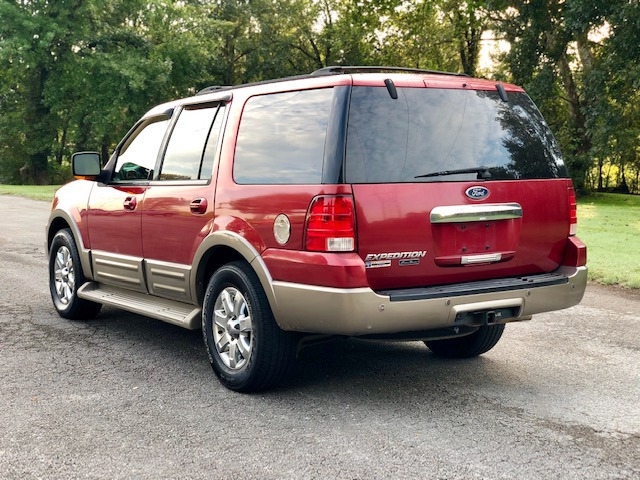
(213, 287, 253, 370)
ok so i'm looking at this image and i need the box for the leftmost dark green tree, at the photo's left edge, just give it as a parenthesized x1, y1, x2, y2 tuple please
(0, 0, 85, 183)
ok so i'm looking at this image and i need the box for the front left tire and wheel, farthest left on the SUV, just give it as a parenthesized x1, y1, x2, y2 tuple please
(49, 228, 102, 320)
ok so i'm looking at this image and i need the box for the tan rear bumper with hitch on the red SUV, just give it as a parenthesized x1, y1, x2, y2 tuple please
(271, 267, 587, 336)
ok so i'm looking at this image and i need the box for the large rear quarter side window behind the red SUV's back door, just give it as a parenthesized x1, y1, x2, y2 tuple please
(233, 88, 333, 184)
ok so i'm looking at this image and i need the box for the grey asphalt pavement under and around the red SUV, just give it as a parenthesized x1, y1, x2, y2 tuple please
(0, 196, 640, 480)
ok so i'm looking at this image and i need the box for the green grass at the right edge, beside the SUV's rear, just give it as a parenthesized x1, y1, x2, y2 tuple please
(578, 193, 640, 288)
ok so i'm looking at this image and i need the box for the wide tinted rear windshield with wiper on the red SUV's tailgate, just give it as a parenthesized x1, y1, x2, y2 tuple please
(345, 87, 567, 183)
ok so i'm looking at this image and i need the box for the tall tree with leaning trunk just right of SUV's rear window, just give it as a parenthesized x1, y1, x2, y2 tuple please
(493, 0, 622, 189)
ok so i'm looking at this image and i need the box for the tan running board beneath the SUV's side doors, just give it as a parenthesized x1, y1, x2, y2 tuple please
(78, 282, 202, 330)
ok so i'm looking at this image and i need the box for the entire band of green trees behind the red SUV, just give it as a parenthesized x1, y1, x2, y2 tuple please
(0, 0, 640, 192)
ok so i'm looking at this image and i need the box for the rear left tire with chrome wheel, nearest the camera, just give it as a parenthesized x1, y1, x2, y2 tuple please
(202, 262, 297, 392)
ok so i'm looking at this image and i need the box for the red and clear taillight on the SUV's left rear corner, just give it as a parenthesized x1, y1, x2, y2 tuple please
(305, 195, 356, 252)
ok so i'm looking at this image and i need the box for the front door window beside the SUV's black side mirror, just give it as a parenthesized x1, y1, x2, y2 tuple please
(113, 116, 169, 182)
